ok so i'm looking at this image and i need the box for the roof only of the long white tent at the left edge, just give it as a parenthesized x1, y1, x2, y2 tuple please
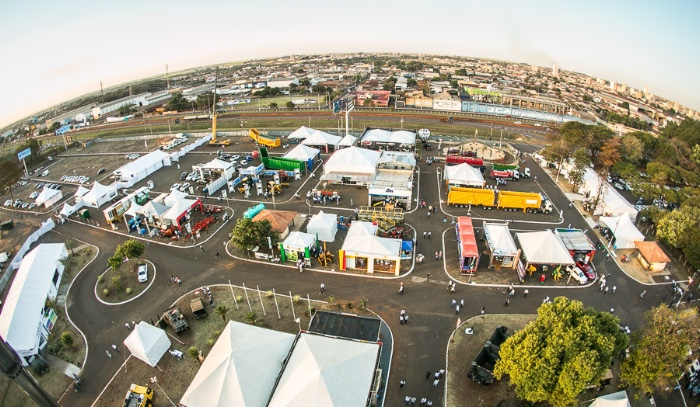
(0, 243, 68, 351)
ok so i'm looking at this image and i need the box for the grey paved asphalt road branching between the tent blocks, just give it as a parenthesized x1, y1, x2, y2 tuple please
(47, 142, 674, 406)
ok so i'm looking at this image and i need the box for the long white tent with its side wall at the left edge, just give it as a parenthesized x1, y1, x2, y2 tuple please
(0, 243, 68, 366)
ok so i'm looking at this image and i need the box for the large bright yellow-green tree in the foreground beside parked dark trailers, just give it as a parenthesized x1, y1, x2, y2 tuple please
(494, 297, 629, 407)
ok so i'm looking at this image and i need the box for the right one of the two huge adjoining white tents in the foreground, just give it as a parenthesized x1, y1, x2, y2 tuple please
(269, 333, 379, 407)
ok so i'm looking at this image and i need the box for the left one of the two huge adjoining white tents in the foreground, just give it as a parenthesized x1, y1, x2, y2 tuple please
(180, 321, 295, 407)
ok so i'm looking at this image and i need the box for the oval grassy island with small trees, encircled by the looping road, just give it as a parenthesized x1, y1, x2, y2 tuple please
(97, 260, 153, 303)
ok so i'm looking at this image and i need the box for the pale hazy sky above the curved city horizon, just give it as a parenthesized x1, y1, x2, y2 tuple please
(0, 0, 700, 128)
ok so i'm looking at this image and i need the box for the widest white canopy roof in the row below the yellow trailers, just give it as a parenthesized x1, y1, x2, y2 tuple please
(515, 230, 574, 265)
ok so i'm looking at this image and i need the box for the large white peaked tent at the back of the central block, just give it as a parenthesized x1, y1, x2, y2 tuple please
(323, 147, 381, 183)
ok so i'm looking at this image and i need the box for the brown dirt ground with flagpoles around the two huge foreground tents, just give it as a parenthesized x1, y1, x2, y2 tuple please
(95, 286, 344, 406)
